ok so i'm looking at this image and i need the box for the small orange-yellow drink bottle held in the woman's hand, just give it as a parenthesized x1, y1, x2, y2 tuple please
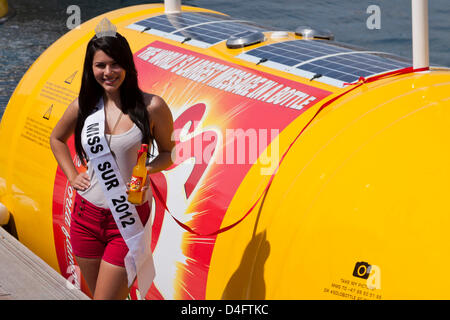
(128, 144, 148, 204)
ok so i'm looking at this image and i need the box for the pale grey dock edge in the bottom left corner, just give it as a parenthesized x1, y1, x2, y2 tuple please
(0, 227, 89, 300)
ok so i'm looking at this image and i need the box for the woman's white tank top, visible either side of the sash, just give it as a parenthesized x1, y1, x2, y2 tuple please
(77, 123, 143, 208)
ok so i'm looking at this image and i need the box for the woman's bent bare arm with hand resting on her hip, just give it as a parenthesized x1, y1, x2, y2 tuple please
(50, 99, 90, 190)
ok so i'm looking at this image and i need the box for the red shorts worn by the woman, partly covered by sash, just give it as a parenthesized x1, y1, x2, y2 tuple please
(70, 193, 150, 267)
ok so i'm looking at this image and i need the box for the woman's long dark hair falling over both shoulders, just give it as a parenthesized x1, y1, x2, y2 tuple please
(75, 33, 153, 165)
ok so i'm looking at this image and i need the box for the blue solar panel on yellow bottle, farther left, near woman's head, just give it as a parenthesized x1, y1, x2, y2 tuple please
(128, 12, 266, 48)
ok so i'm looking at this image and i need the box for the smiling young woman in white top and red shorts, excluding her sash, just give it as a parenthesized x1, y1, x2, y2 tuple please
(50, 26, 174, 299)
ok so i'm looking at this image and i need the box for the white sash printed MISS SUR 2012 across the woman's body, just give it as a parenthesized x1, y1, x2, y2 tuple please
(81, 98, 155, 297)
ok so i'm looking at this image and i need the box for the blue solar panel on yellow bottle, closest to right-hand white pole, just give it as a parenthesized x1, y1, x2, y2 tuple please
(238, 40, 411, 87)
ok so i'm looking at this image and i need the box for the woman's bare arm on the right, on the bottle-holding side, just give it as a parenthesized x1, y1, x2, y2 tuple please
(147, 95, 175, 174)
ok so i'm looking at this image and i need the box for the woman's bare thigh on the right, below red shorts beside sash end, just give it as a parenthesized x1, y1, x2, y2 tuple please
(94, 260, 129, 300)
